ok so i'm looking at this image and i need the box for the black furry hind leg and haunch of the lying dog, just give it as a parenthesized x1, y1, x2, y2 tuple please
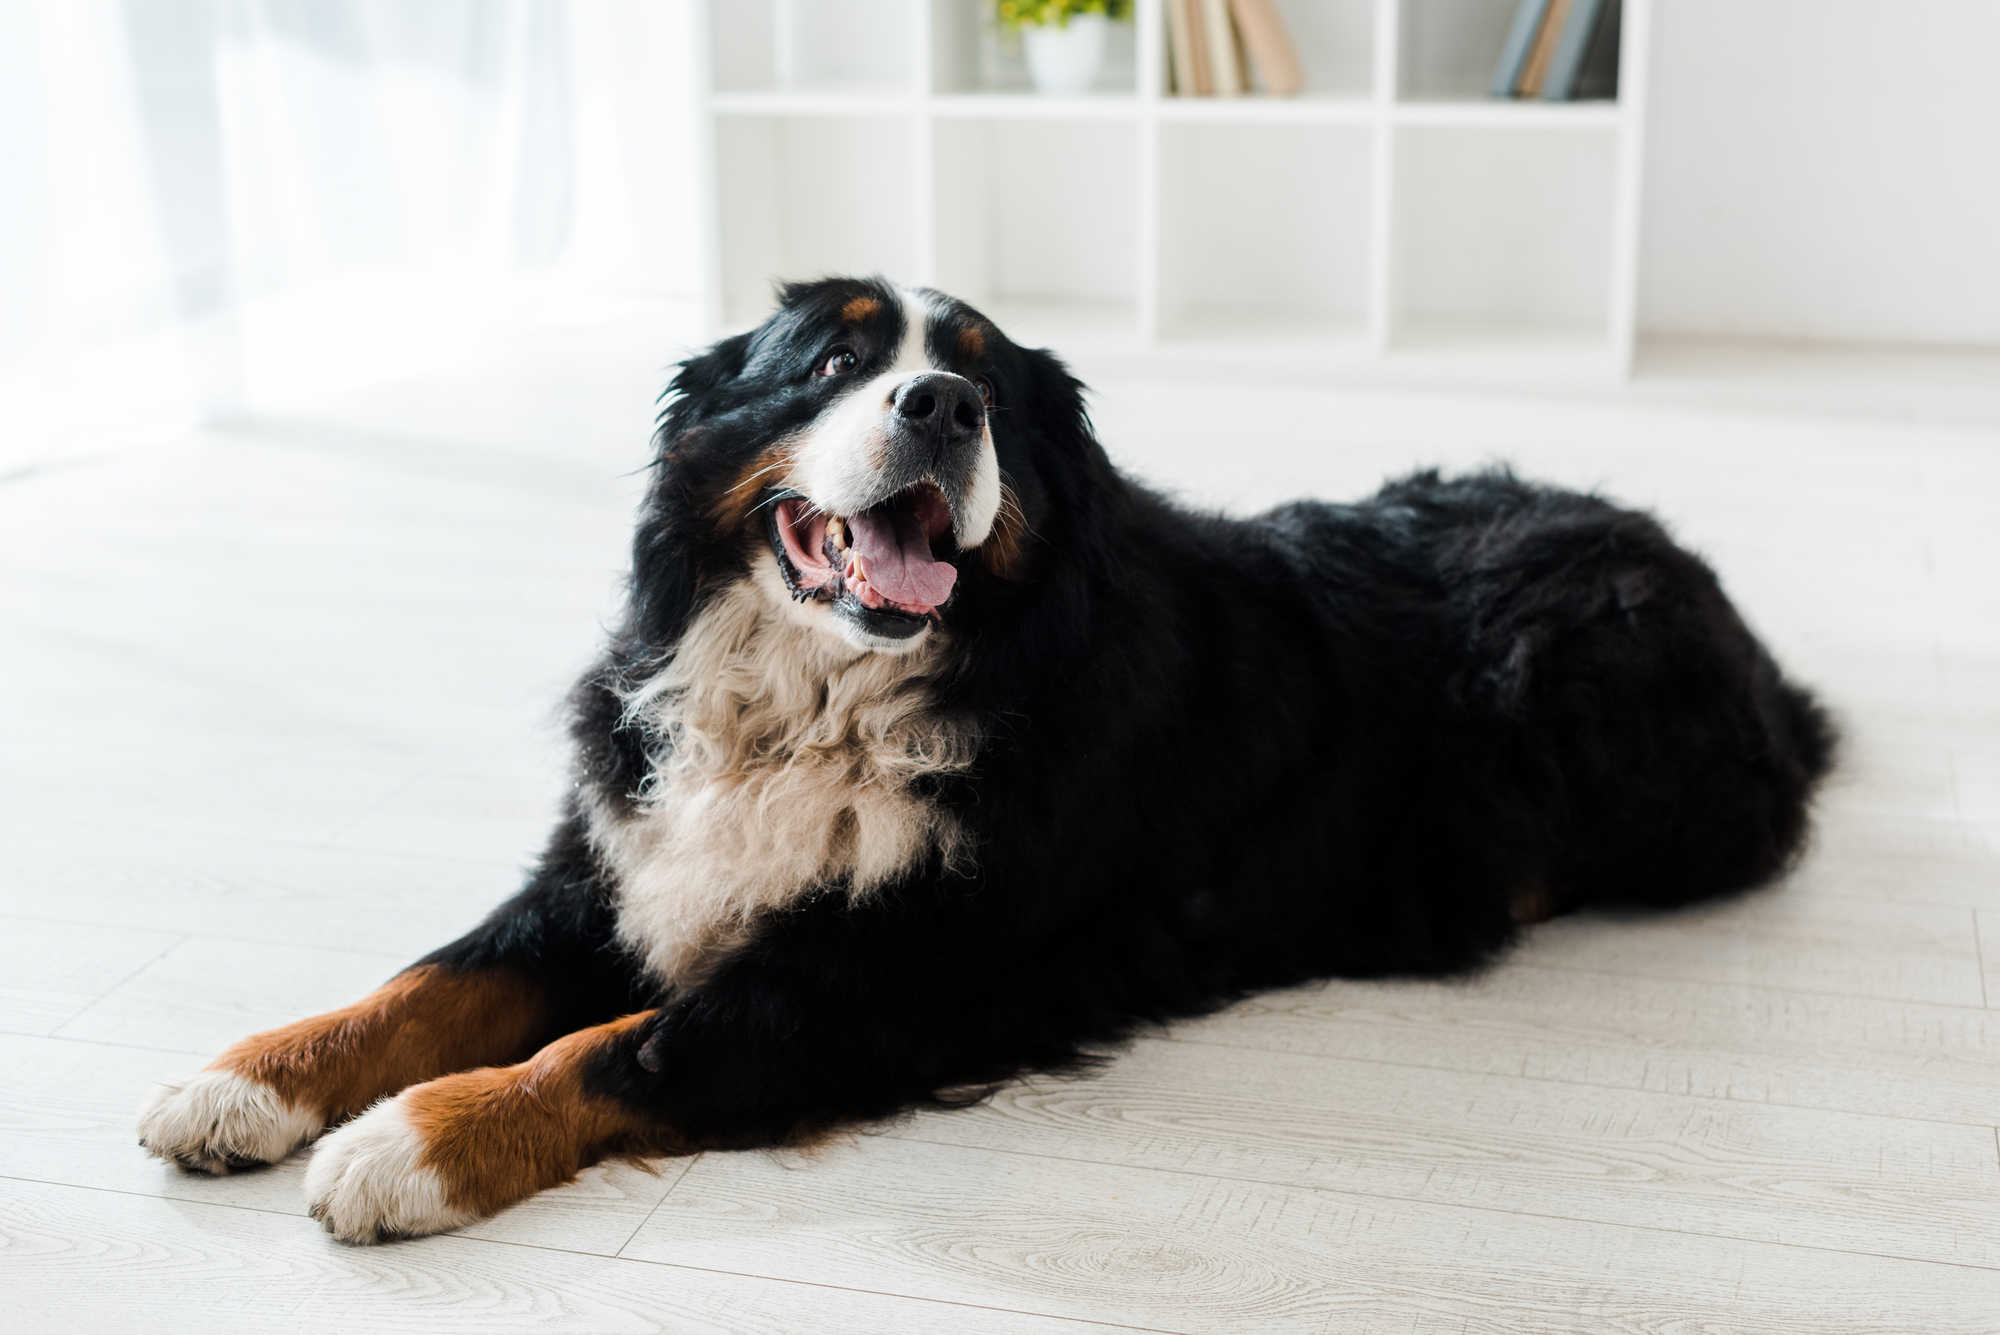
(1456, 496, 1834, 907)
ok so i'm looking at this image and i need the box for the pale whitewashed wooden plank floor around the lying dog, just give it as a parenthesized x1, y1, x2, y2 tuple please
(0, 322, 2000, 1335)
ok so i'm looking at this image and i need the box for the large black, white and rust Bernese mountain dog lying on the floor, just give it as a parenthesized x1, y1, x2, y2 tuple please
(138, 280, 1834, 1243)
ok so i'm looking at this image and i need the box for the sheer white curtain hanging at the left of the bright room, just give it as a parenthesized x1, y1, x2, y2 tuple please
(0, 0, 698, 472)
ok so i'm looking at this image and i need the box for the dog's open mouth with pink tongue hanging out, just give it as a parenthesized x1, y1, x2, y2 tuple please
(768, 482, 958, 630)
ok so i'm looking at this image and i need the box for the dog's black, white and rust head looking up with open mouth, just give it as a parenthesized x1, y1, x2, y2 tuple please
(634, 280, 1102, 654)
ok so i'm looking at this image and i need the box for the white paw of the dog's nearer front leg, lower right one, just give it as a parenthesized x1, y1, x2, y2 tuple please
(306, 1095, 480, 1243)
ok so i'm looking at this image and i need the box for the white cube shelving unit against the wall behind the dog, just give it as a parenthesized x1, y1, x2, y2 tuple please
(702, 0, 1648, 374)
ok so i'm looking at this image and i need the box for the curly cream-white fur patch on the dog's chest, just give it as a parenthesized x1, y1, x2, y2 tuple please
(590, 580, 974, 985)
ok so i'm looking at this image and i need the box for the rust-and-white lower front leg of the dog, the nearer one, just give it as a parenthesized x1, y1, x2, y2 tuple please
(306, 1011, 656, 1243)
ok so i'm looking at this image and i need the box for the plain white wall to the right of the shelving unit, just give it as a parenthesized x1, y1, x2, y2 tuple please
(1640, 0, 2000, 344)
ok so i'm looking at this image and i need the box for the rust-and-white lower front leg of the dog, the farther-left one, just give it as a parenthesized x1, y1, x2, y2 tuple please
(138, 963, 544, 1173)
